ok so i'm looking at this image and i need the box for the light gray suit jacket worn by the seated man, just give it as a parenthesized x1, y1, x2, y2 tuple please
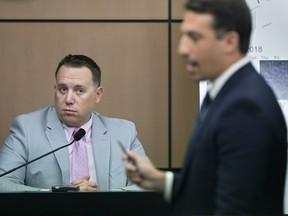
(0, 106, 145, 192)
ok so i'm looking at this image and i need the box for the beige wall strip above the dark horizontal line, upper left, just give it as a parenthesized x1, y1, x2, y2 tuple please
(0, 0, 168, 20)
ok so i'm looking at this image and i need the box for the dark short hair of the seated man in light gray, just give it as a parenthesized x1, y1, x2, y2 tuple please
(55, 54, 101, 86)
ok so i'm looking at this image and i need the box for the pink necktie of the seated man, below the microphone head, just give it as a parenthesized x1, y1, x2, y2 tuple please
(72, 128, 89, 181)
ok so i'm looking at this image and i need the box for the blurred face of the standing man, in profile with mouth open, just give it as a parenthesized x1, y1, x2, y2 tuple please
(179, 11, 225, 81)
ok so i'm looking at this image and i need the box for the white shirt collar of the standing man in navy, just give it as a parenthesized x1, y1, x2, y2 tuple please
(207, 56, 249, 100)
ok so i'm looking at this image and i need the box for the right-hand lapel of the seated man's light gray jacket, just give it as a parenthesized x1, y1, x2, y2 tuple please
(92, 113, 111, 191)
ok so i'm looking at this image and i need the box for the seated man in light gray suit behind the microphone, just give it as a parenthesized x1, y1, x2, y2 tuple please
(0, 55, 146, 192)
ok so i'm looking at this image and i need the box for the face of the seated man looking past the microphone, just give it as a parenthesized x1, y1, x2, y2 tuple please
(54, 66, 103, 127)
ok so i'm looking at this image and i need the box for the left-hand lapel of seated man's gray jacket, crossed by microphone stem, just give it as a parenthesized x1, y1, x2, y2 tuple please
(46, 107, 70, 184)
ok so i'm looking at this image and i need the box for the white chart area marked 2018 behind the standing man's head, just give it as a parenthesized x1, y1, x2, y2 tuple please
(246, 0, 288, 70)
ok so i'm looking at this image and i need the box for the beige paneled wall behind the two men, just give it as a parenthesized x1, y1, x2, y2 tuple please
(0, 0, 198, 168)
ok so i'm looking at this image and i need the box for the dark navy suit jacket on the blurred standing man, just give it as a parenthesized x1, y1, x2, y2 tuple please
(172, 63, 287, 215)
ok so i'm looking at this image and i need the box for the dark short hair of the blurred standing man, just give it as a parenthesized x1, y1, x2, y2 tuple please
(185, 0, 252, 54)
